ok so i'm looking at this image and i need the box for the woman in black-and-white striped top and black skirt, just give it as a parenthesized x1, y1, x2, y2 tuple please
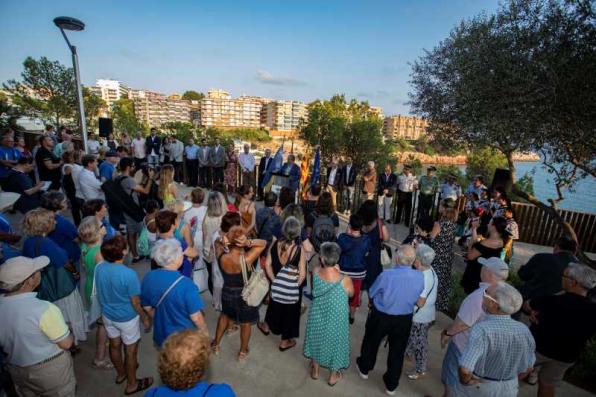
(265, 216, 306, 351)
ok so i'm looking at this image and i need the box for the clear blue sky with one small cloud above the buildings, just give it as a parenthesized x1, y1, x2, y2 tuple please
(0, 0, 498, 115)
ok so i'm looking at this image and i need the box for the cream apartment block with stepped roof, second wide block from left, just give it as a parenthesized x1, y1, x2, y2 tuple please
(200, 90, 264, 128)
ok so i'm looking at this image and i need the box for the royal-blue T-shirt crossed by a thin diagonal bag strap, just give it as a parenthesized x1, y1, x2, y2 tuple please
(141, 269, 203, 346)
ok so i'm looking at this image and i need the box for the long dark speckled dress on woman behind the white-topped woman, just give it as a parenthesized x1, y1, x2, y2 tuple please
(431, 220, 457, 312)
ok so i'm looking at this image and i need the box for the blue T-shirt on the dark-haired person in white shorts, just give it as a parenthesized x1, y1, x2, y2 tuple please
(95, 262, 141, 323)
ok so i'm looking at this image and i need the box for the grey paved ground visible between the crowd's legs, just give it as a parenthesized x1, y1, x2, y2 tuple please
(3, 184, 592, 397)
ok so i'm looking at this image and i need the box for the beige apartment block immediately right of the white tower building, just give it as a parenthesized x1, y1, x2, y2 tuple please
(129, 90, 192, 127)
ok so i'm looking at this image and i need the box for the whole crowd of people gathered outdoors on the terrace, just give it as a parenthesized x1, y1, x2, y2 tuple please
(0, 127, 596, 397)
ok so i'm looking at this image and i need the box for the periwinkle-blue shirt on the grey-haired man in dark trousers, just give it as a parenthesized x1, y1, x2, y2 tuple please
(368, 266, 424, 316)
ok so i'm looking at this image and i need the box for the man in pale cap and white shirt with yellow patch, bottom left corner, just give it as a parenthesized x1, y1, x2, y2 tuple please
(0, 256, 76, 397)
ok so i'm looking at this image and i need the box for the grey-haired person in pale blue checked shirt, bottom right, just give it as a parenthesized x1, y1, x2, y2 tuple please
(454, 281, 536, 397)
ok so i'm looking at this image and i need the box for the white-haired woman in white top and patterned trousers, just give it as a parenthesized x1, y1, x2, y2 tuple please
(406, 244, 439, 380)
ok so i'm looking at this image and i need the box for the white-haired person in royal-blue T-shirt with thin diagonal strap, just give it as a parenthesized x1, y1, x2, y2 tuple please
(141, 238, 209, 346)
